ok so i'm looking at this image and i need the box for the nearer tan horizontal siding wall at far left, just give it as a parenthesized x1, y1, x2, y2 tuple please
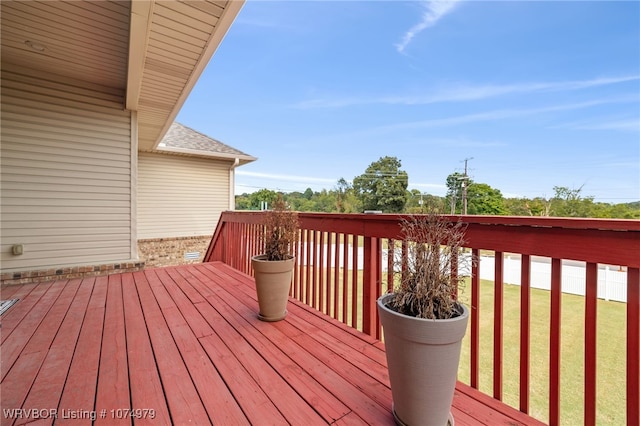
(1, 67, 135, 272)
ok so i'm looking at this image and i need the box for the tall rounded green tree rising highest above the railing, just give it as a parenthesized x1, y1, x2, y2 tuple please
(353, 157, 409, 213)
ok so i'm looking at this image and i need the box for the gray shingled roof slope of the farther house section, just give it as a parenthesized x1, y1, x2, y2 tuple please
(158, 122, 255, 162)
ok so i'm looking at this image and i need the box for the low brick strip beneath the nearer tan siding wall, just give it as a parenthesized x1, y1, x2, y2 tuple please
(0, 262, 145, 284)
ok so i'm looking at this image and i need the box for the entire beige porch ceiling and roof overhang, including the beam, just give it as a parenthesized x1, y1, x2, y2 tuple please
(0, 0, 244, 151)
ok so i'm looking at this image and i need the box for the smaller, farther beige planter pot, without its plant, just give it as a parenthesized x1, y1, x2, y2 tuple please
(251, 255, 295, 321)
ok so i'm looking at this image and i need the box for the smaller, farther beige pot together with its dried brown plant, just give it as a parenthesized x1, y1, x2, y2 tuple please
(251, 195, 299, 321)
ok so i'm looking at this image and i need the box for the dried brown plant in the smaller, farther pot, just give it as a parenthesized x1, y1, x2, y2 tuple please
(263, 195, 300, 260)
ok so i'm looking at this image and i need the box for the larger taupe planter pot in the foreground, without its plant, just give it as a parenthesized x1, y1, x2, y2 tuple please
(378, 294, 469, 426)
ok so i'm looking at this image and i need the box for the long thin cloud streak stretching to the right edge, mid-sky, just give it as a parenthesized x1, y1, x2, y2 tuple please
(294, 75, 640, 109)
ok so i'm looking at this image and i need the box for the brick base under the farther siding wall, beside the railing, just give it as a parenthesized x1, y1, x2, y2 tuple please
(138, 235, 211, 267)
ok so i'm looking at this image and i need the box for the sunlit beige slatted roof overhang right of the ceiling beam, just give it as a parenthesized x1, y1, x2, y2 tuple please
(132, 0, 244, 151)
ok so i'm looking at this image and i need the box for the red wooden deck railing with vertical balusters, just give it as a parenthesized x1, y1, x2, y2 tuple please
(205, 212, 640, 425)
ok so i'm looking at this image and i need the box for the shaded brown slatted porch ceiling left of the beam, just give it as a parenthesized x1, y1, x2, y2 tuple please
(0, 0, 130, 93)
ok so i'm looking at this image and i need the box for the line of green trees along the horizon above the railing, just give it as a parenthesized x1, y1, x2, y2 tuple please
(236, 157, 640, 219)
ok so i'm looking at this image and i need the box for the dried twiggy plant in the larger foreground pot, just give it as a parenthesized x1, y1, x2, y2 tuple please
(388, 213, 474, 319)
